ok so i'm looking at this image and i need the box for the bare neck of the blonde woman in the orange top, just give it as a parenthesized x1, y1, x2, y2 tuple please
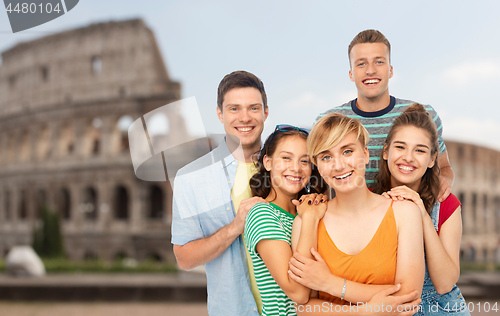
(332, 185, 373, 214)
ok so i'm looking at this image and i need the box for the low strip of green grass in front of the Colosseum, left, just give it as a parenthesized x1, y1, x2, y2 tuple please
(0, 258, 177, 273)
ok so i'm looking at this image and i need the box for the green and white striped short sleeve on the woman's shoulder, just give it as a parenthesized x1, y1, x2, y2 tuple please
(244, 203, 290, 253)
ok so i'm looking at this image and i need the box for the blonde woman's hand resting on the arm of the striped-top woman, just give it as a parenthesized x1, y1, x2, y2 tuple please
(288, 248, 333, 292)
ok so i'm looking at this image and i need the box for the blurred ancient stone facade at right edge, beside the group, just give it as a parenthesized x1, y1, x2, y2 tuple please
(446, 141, 500, 264)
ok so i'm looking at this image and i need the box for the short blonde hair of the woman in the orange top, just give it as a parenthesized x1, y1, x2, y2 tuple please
(307, 113, 370, 164)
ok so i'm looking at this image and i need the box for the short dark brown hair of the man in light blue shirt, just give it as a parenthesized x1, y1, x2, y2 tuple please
(217, 70, 267, 112)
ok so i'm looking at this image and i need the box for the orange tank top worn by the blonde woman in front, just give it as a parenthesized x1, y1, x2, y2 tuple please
(318, 203, 398, 305)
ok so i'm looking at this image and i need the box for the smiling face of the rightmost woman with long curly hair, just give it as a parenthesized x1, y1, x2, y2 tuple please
(383, 126, 436, 191)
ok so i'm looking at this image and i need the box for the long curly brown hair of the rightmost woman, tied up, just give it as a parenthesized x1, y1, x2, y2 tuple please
(375, 103, 440, 214)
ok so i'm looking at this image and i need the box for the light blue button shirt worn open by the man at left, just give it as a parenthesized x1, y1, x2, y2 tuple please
(172, 139, 259, 316)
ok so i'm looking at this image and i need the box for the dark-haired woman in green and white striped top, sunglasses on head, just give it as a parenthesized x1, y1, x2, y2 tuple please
(244, 125, 327, 316)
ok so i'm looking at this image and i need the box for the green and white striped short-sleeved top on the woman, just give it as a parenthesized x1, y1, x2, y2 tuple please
(245, 203, 297, 316)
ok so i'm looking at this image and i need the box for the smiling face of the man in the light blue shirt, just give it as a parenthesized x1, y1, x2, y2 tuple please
(217, 87, 268, 149)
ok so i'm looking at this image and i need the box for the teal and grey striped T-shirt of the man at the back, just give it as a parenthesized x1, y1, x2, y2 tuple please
(315, 96, 446, 188)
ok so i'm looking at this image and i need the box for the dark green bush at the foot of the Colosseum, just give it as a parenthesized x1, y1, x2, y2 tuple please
(33, 206, 64, 258)
